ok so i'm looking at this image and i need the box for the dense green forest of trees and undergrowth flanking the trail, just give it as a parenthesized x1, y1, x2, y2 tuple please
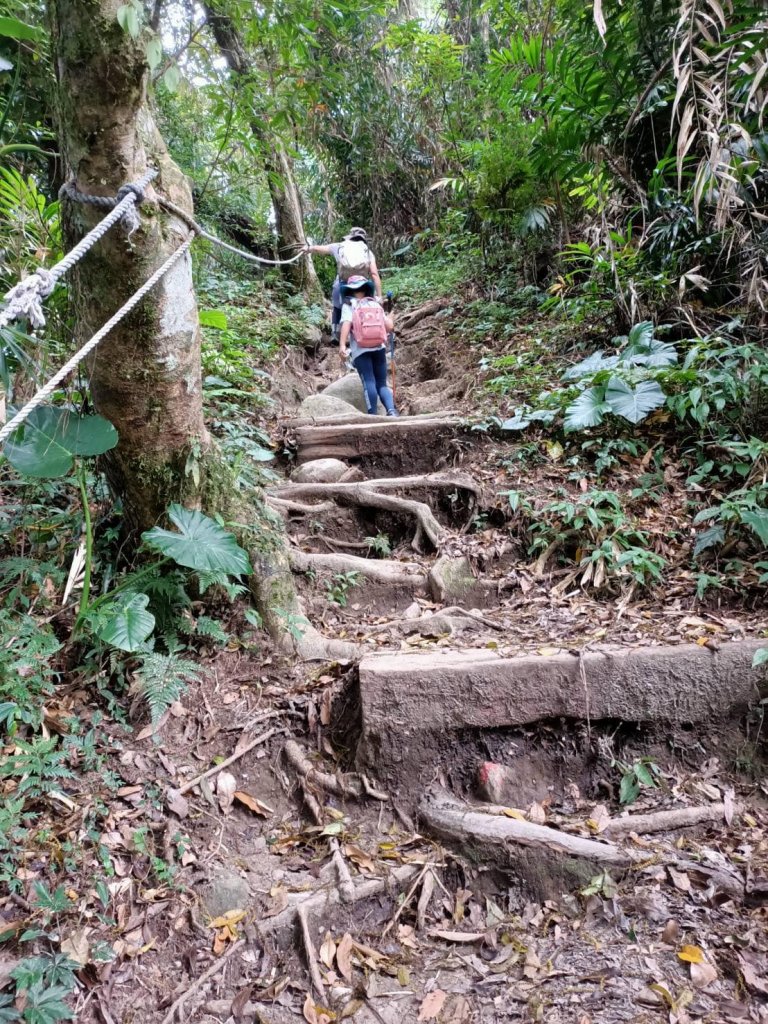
(0, 0, 768, 1024)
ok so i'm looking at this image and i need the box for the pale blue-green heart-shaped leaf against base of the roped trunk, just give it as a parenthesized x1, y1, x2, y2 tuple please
(142, 505, 253, 575)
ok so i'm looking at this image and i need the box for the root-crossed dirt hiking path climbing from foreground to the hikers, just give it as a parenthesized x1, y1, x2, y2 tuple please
(57, 303, 768, 1024)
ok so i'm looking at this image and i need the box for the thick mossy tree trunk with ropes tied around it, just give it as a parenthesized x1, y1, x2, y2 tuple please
(49, 0, 352, 657)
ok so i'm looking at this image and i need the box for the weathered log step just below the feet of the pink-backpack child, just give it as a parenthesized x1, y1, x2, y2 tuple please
(296, 417, 468, 469)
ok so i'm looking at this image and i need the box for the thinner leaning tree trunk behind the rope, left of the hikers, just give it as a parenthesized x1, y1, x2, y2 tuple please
(205, 3, 323, 301)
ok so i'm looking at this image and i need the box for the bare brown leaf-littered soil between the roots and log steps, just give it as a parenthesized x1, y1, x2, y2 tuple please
(0, 299, 768, 1024)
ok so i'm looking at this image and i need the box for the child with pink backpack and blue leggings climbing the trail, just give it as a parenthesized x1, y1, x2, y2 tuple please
(339, 274, 399, 416)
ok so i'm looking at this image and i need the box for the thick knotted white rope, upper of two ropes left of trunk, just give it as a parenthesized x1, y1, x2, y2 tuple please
(0, 170, 158, 328)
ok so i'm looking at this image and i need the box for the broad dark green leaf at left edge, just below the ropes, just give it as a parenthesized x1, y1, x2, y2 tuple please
(3, 406, 118, 478)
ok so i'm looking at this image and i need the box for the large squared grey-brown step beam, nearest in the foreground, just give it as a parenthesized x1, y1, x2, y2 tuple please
(357, 640, 765, 786)
